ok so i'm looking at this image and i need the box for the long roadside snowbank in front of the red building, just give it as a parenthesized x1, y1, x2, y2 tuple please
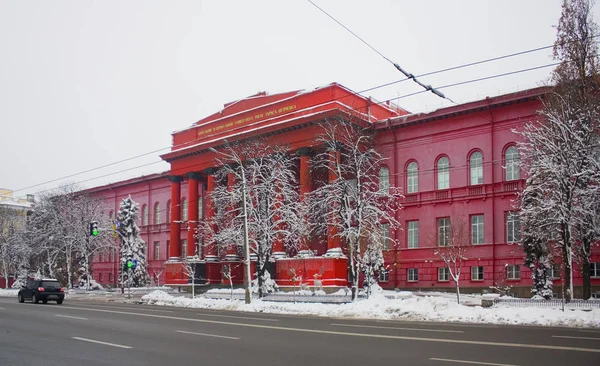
(142, 291, 600, 327)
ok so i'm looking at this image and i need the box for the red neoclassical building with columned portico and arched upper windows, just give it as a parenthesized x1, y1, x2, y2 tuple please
(89, 84, 600, 296)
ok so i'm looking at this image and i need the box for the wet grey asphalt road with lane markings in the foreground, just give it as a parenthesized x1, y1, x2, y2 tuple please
(0, 297, 600, 366)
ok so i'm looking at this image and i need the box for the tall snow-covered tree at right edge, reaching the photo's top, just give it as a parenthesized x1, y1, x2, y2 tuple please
(519, 0, 600, 300)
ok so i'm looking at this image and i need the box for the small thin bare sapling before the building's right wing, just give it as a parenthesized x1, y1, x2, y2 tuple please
(434, 219, 471, 304)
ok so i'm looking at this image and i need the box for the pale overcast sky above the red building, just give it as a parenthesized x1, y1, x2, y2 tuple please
(0, 0, 598, 195)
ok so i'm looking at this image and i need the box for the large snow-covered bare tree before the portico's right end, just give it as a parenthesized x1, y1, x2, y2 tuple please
(308, 119, 402, 300)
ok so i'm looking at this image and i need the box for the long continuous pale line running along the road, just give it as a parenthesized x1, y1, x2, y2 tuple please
(52, 306, 600, 353)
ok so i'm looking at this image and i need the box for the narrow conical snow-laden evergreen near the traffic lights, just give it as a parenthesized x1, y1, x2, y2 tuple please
(117, 196, 150, 287)
